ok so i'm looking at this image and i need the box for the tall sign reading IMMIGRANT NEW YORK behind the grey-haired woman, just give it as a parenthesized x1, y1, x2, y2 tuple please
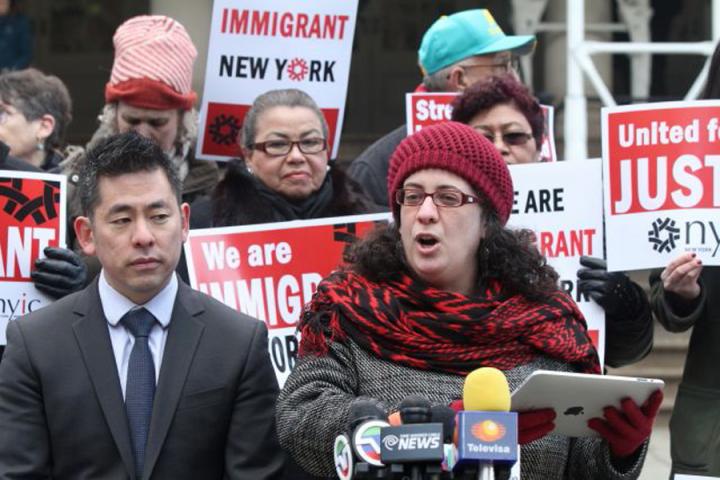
(197, 0, 358, 160)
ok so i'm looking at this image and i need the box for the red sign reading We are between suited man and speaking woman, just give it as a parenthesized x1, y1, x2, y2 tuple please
(185, 213, 390, 386)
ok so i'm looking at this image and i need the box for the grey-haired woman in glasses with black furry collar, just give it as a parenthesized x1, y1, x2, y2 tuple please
(191, 89, 373, 228)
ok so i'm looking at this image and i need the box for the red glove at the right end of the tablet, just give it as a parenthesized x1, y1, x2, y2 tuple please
(588, 390, 663, 458)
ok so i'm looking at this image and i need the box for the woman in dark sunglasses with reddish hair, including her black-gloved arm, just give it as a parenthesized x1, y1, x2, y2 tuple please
(452, 75, 653, 367)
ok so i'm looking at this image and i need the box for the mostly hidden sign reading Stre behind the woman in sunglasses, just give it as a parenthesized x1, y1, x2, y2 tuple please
(405, 92, 557, 162)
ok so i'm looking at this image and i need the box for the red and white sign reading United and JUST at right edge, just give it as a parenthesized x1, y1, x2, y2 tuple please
(602, 100, 720, 270)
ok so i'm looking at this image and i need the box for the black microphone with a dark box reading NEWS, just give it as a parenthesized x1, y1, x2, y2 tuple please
(381, 395, 444, 480)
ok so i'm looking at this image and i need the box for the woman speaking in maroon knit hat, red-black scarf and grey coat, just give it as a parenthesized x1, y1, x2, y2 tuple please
(277, 122, 661, 480)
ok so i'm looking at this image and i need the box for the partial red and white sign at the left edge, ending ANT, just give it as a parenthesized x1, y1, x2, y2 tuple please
(0, 170, 66, 345)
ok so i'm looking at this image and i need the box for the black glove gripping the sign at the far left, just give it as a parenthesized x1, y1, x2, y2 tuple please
(30, 247, 87, 299)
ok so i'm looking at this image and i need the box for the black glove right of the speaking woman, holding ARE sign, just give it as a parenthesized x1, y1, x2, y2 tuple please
(577, 256, 647, 317)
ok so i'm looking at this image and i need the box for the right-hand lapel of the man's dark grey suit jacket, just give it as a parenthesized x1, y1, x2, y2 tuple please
(143, 281, 205, 478)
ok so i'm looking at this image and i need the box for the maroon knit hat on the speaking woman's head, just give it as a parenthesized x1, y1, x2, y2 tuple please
(388, 122, 513, 225)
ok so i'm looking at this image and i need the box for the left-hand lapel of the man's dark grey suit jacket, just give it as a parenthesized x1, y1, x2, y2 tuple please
(73, 280, 135, 478)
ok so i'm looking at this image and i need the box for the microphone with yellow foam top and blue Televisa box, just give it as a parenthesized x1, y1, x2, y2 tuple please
(456, 367, 518, 480)
